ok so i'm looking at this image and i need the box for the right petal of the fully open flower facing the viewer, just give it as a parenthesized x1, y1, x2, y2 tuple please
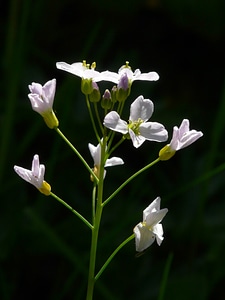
(139, 122, 168, 142)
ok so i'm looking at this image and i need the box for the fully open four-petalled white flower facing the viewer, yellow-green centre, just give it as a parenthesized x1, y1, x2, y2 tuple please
(103, 96, 168, 148)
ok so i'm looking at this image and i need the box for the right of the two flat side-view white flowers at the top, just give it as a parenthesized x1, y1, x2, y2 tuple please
(101, 62, 159, 84)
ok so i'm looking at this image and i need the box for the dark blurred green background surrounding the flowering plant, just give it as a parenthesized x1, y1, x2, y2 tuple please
(0, 0, 225, 300)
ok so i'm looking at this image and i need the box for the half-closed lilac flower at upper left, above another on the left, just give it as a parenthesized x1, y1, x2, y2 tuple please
(28, 79, 59, 129)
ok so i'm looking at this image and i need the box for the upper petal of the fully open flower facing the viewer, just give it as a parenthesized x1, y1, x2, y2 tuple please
(130, 96, 154, 122)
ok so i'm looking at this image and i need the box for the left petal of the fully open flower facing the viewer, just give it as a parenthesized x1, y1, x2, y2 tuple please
(103, 111, 128, 134)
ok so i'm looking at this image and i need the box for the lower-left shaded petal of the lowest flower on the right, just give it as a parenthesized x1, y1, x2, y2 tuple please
(134, 223, 155, 252)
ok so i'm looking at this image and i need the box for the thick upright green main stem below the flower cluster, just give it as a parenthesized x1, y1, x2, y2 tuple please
(86, 138, 106, 300)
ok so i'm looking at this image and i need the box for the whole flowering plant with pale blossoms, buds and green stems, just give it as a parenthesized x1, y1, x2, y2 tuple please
(14, 61, 203, 300)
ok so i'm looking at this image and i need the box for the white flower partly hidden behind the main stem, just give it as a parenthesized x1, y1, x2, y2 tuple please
(88, 143, 124, 177)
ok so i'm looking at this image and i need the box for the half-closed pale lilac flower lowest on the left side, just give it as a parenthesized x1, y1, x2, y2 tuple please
(14, 154, 51, 196)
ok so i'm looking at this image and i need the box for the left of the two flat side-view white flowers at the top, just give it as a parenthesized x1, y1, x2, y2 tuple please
(56, 60, 102, 82)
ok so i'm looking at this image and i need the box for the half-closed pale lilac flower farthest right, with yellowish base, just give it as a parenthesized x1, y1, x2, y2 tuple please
(159, 119, 203, 160)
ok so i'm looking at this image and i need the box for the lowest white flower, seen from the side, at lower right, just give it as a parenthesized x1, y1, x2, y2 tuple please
(134, 197, 168, 252)
